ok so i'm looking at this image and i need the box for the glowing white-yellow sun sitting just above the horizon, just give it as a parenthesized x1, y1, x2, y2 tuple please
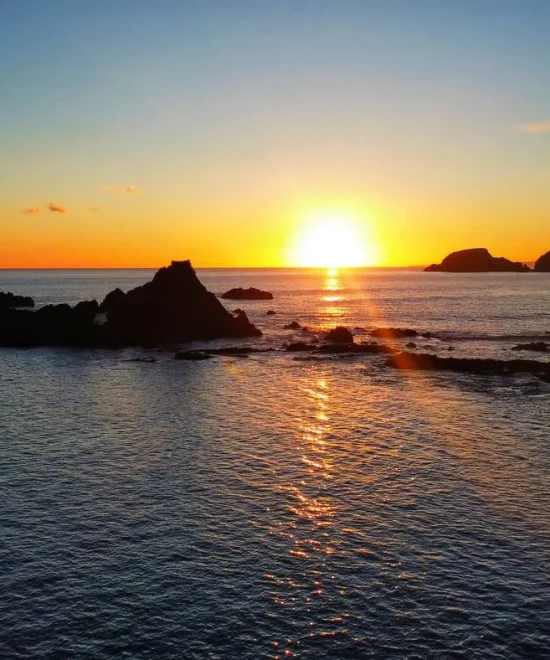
(289, 211, 378, 268)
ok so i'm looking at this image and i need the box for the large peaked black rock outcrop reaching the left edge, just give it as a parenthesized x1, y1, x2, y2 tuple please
(0, 261, 262, 346)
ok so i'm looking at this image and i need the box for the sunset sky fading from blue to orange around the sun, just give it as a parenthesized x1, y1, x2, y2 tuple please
(0, 0, 550, 268)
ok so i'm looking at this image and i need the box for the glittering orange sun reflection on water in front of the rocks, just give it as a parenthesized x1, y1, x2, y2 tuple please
(269, 378, 356, 660)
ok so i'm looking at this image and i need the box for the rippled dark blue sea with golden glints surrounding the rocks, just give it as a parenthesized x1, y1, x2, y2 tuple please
(0, 270, 550, 660)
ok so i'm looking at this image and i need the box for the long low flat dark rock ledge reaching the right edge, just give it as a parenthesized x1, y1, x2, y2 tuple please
(386, 351, 550, 376)
